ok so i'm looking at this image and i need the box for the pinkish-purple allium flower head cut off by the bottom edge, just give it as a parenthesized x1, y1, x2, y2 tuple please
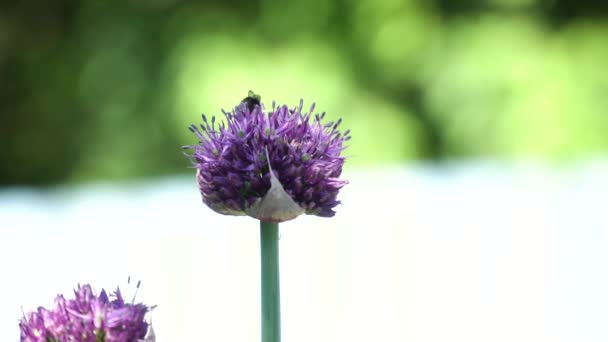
(19, 285, 154, 342)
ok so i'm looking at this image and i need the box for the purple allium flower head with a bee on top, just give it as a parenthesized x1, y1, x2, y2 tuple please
(184, 91, 350, 222)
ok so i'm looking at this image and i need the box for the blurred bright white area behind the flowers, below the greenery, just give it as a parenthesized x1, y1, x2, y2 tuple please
(0, 162, 608, 342)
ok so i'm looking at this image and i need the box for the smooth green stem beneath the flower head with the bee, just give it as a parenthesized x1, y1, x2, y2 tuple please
(260, 221, 281, 342)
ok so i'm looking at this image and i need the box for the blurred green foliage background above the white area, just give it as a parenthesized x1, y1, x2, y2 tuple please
(0, 0, 608, 185)
